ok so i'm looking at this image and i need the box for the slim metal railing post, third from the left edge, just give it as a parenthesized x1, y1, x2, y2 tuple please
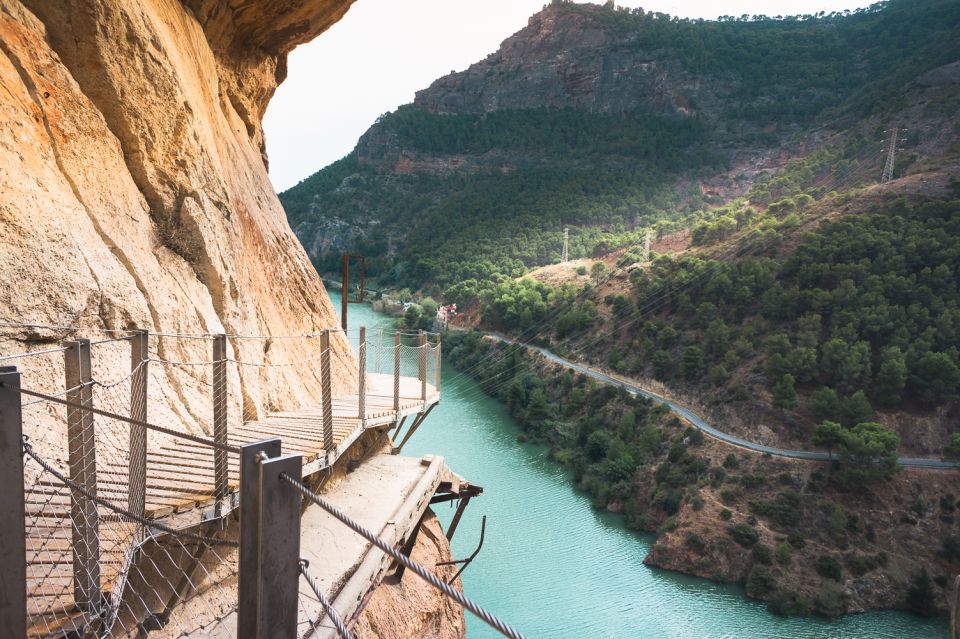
(127, 331, 150, 517)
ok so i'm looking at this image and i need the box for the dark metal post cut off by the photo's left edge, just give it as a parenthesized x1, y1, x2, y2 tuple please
(0, 366, 27, 637)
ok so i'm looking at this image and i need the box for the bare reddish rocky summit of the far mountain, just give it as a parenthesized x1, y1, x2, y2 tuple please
(414, 5, 738, 117)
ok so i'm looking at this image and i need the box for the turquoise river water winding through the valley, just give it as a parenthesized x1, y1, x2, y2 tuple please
(331, 293, 949, 639)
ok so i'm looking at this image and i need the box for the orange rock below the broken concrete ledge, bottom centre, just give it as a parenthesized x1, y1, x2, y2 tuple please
(353, 511, 466, 639)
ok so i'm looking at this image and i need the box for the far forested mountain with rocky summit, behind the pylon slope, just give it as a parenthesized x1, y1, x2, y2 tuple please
(281, 0, 960, 292)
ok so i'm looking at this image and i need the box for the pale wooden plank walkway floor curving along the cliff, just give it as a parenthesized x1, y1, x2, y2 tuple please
(25, 373, 440, 637)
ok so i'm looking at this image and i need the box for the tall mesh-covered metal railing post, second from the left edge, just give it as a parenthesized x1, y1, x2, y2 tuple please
(63, 339, 101, 615)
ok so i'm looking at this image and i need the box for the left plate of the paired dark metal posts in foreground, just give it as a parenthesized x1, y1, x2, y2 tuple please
(237, 438, 282, 639)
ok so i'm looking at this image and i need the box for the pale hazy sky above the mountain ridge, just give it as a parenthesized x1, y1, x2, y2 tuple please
(264, 0, 872, 191)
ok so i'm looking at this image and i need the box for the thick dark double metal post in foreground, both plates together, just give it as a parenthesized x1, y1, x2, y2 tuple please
(237, 440, 302, 639)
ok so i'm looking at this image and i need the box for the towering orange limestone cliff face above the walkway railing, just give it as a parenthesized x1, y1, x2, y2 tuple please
(0, 0, 356, 418)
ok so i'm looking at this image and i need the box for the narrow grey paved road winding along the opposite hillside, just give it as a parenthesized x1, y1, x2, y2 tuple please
(487, 332, 960, 469)
